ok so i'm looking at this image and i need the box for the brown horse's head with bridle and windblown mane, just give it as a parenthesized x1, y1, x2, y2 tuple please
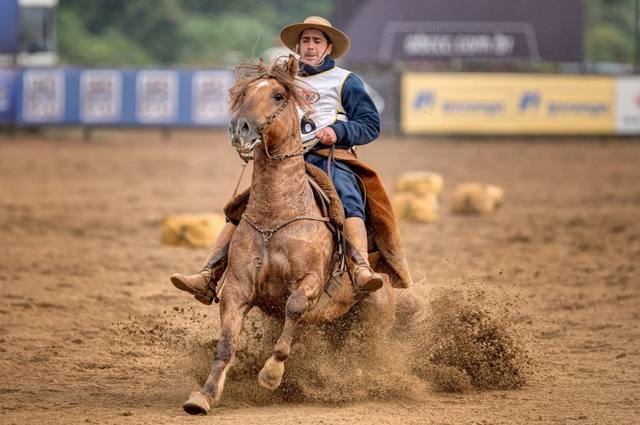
(229, 56, 309, 159)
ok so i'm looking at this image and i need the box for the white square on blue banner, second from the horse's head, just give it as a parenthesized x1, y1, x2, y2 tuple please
(136, 71, 178, 123)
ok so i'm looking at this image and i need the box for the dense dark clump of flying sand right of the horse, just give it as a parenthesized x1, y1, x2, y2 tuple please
(422, 289, 530, 392)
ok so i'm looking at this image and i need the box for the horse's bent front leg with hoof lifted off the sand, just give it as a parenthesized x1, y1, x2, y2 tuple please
(258, 273, 321, 390)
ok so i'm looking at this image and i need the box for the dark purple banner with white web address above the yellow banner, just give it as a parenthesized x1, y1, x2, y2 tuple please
(334, 0, 584, 63)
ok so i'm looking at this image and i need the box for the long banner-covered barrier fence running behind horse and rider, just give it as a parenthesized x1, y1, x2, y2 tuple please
(0, 69, 640, 135)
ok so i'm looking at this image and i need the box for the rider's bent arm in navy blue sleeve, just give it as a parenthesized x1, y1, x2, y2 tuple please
(330, 74, 380, 148)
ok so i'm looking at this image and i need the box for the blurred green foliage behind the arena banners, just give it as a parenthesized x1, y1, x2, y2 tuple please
(57, 0, 638, 66)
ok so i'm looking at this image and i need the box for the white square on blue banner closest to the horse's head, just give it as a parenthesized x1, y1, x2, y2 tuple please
(191, 71, 233, 124)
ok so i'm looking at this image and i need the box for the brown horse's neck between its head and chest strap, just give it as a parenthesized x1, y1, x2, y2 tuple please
(246, 137, 313, 225)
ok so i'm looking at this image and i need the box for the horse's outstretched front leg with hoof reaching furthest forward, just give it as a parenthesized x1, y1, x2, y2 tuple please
(182, 278, 252, 415)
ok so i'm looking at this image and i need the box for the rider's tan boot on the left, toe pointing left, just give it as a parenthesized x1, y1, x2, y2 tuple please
(170, 223, 236, 305)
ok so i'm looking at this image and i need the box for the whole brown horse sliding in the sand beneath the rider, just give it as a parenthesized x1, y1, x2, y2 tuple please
(183, 56, 404, 414)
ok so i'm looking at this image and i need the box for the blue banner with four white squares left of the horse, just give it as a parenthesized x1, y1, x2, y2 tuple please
(18, 69, 233, 127)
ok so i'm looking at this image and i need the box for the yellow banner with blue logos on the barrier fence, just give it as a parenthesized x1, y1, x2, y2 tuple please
(401, 73, 615, 134)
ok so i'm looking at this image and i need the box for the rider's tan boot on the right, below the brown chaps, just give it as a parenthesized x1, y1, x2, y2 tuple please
(344, 217, 383, 292)
